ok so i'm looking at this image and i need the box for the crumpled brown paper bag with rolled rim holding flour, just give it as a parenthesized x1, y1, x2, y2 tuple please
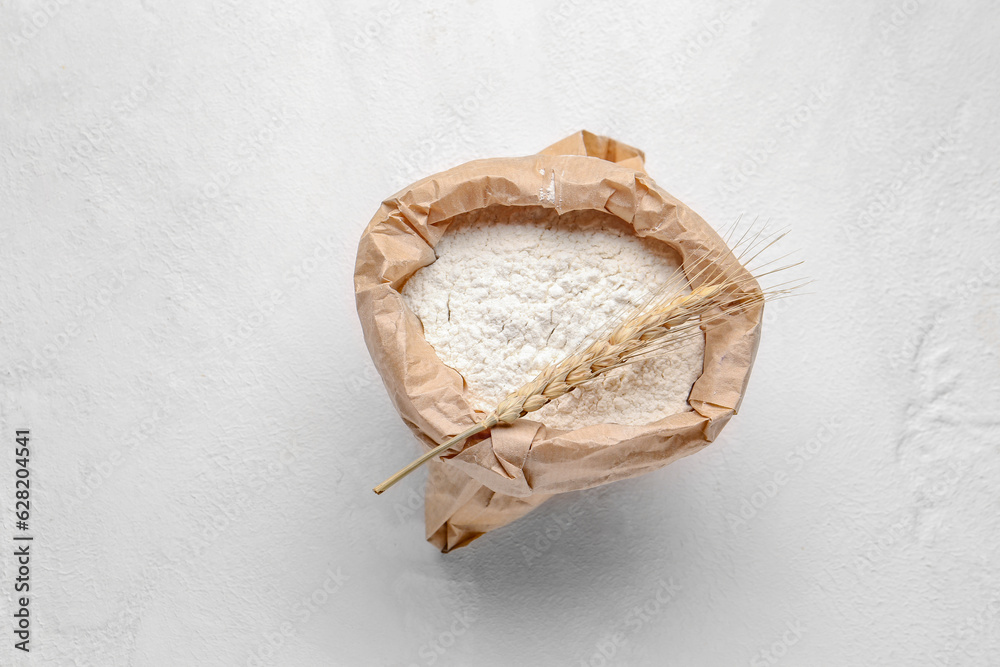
(354, 132, 763, 552)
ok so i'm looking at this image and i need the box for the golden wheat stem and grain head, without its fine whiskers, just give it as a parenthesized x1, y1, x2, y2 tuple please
(373, 281, 764, 494)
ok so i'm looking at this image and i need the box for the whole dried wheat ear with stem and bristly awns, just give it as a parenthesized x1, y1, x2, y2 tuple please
(373, 224, 801, 494)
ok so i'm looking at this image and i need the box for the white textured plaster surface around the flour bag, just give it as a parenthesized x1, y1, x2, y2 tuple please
(0, 0, 1000, 667)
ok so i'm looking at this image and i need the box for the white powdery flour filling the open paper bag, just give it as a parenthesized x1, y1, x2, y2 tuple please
(403, 208, 704, 429)
